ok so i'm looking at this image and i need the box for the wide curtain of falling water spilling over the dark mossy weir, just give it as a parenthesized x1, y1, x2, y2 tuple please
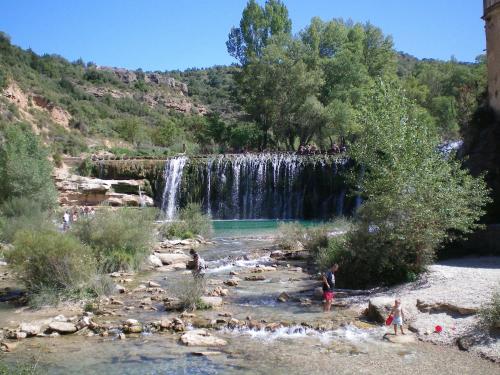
(162, 153, 354, 220)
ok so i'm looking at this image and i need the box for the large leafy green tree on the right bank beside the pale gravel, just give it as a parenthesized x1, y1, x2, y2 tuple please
(343, 83, 489, 286)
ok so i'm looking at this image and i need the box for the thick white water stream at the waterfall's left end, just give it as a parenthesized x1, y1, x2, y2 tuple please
(161, 156, 187, 220)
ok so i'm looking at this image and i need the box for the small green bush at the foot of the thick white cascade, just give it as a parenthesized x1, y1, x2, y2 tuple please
(159, 203, 212, 239)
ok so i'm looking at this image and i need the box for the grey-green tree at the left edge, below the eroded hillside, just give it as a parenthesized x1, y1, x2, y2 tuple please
(0, 125, 56, 208)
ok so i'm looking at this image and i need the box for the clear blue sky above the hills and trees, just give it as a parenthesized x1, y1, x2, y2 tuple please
(0, 0, 485, 70)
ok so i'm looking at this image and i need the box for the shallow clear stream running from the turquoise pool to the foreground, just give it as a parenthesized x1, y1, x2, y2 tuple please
(0, 221, 500, 375)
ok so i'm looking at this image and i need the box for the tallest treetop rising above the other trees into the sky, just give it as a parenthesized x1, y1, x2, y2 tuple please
(226, 0, 292, 65)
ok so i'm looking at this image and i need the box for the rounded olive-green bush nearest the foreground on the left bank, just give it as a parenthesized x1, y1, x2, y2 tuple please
(7, 230, 96, 298)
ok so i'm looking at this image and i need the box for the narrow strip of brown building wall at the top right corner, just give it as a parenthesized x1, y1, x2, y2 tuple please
(484, 0, 500, 116)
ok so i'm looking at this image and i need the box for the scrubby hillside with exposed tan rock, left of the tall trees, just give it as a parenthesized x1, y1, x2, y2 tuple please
(0, 34, 209, 159)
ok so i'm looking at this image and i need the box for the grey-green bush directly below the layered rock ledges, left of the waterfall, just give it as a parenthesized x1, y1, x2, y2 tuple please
(72, 208, 154, 272)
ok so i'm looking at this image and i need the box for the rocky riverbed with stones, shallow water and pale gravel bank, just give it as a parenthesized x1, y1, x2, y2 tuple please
(0, 238, 500, 374)
